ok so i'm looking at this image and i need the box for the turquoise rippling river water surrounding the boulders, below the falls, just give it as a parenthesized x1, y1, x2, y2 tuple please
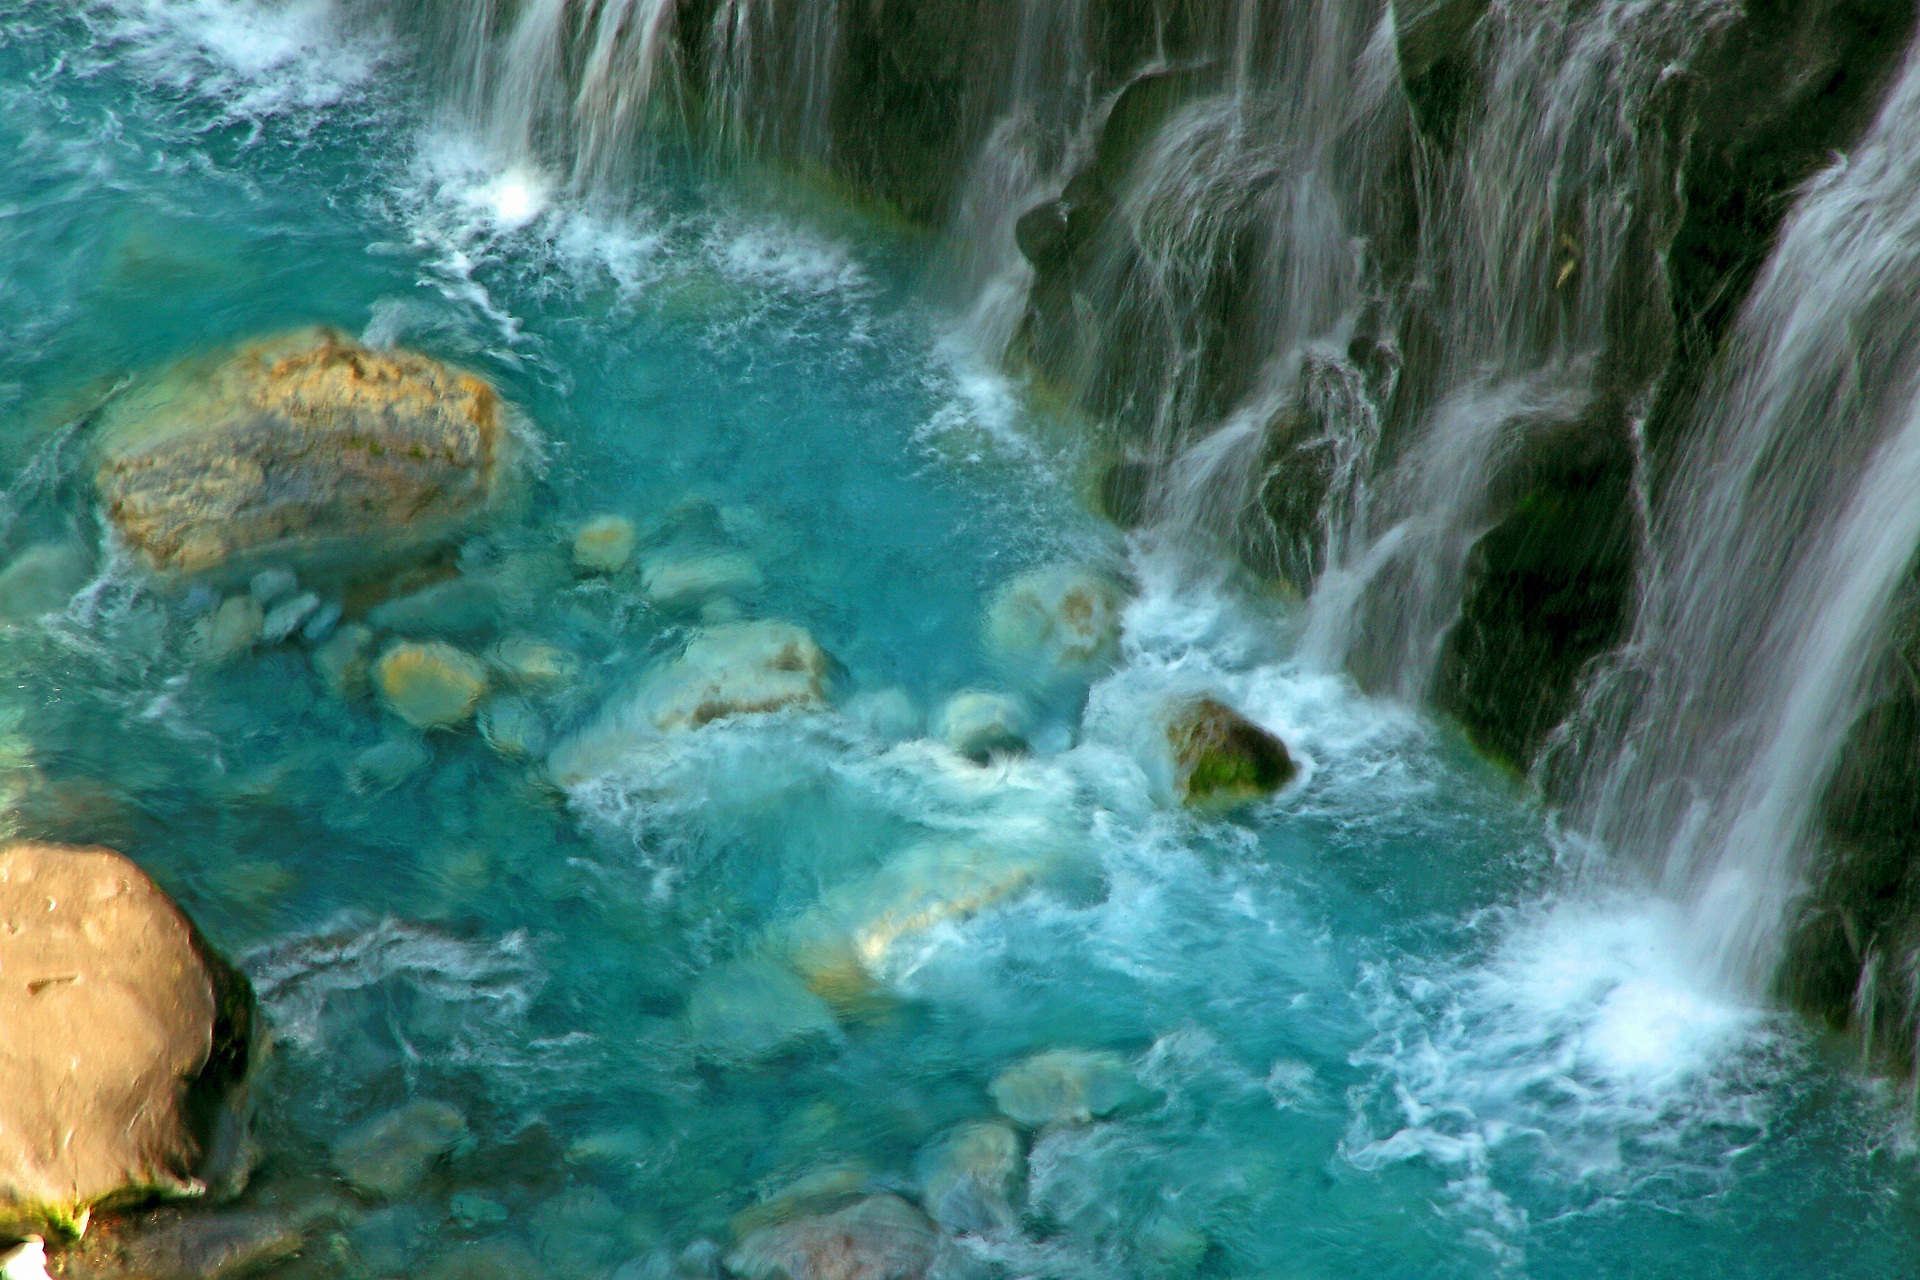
(0, 0, 1920, 1280)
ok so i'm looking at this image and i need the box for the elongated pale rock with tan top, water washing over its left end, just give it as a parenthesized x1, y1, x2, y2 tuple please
(547, 622, 831, 787)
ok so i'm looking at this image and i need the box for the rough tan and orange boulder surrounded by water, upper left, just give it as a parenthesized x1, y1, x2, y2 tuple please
(94, 328, 511, 574)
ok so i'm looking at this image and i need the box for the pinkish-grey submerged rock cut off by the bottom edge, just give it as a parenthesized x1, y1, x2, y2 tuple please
(726, 1196, 939, 1280)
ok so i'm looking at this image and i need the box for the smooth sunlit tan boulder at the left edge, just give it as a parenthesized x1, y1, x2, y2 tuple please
(0, 844, 253, 1238)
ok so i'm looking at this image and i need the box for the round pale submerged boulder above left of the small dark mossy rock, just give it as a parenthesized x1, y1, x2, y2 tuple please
(985, 564, 1127, 679)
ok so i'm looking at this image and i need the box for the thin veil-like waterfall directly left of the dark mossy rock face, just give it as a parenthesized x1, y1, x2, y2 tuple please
(1309, 0, 1734, 700)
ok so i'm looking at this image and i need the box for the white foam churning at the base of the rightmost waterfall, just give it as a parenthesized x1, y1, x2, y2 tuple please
(1344, 892, 1793, 1232)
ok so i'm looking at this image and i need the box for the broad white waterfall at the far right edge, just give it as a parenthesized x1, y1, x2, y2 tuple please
(1572, 40, 1920, 990)
